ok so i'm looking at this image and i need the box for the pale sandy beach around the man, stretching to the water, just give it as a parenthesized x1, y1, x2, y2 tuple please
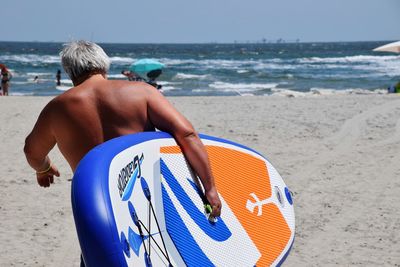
(0, 94, 400, 266)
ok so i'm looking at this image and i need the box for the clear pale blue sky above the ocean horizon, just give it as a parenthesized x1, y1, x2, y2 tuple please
(0, 0, 400, 43)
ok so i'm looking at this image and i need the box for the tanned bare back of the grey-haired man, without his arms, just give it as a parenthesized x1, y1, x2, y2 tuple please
(43, 76, 158, 170)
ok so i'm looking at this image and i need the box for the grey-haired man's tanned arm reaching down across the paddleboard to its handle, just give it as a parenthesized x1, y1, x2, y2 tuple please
(148, 86, 221, 217)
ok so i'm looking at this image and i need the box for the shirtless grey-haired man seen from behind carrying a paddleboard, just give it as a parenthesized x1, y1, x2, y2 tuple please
(24, 41, 221, 220)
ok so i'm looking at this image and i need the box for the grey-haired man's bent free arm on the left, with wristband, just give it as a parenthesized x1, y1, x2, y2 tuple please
(24, 103, 60, 187)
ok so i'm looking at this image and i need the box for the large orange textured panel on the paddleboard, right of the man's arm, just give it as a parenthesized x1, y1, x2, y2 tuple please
(206, 146, 291, 266)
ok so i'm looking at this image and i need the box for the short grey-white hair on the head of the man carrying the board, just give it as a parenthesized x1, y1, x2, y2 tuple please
(60, 40, 110, 81)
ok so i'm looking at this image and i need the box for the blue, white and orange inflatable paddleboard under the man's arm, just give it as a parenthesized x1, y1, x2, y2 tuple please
(72, 132, 295, 267)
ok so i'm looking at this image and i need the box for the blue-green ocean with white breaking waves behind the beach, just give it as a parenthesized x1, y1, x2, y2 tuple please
(0, 41, 400, 96)
